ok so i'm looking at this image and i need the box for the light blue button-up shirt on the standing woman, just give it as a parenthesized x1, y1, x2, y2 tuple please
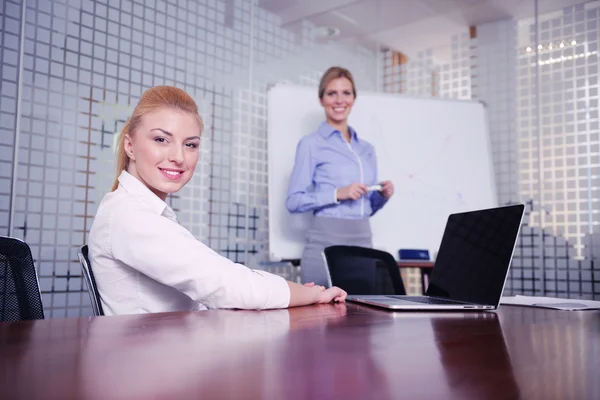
(285, 122, 387, 219)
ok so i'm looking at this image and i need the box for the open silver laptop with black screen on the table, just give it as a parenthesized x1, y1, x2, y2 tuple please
(346, 204, 525, 311)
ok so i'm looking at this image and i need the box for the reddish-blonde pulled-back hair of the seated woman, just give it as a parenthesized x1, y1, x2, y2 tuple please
(112, 86, 204, 191)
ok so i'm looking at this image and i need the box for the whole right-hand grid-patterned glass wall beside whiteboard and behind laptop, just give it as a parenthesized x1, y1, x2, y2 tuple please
(383, 1, 600, 299)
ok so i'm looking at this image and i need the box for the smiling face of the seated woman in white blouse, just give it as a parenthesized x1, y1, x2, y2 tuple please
(124, 107, 201, 200)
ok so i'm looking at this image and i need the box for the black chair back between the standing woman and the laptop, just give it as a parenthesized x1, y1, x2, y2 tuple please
(324, 246, 406, 295)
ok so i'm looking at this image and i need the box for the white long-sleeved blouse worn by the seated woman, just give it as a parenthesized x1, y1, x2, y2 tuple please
(88, 171, 290, 315)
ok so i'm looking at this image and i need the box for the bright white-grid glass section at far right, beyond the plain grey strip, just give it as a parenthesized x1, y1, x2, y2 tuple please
(516, 1, 600, 297)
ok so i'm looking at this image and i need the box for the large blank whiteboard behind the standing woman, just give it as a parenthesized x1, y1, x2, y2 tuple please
(267, 84, 497, 261)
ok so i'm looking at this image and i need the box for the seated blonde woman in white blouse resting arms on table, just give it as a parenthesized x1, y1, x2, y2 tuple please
(88, 86, 346, 315)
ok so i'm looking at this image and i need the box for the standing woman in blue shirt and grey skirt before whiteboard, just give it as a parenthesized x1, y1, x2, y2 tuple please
(286, 67, 394, 286)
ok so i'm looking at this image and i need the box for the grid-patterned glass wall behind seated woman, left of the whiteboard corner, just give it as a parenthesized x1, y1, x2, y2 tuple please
(0, 0, 377, 317)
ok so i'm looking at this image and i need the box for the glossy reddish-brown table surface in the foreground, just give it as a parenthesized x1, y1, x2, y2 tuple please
(0, 303, 600, 400)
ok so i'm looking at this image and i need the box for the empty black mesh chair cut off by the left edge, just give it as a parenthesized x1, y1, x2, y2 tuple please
(0, 237, 44, 321)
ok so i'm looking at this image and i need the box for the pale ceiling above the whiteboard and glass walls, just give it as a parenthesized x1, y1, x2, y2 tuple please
(259, 0, 584, 60)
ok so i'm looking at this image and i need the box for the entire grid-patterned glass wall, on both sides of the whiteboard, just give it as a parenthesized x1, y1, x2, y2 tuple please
(0, 0, 600, 317)
